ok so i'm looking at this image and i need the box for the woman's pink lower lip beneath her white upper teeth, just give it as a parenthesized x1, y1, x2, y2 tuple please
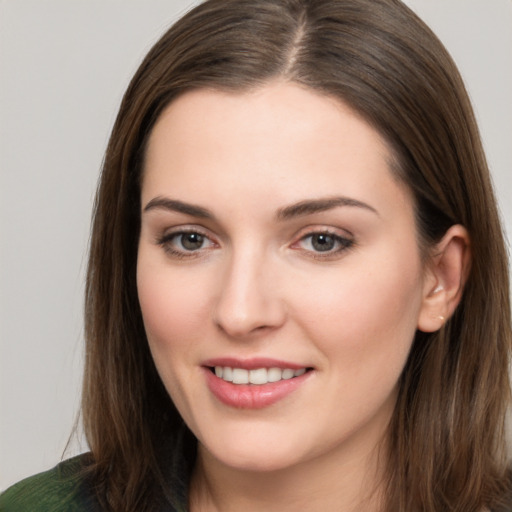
(203, 368, 312, 409)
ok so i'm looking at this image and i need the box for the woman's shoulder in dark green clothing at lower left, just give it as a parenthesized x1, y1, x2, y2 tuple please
(0, 454, 100, 512)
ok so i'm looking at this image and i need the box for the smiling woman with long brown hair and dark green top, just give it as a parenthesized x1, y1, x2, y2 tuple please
(3, 0, 511, 512)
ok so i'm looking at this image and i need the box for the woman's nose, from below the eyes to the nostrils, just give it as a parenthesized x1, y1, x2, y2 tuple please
(214, 250, 286, 338)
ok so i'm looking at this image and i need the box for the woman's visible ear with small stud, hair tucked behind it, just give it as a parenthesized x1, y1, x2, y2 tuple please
(418, 224, 471, 332)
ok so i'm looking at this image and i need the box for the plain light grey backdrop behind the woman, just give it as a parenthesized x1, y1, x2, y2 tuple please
(0, 0, 512, 489)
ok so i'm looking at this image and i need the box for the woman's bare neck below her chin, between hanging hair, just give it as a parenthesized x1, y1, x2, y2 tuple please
(190, 434, 386, 512)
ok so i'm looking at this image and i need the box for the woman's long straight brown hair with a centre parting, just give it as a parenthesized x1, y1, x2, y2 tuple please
(83, 0, 511, 512)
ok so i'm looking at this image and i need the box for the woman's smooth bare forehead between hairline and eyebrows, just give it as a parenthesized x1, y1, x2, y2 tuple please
(142, 83, 412, 220)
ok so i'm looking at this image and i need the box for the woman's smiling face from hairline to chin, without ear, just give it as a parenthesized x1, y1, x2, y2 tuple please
(137, 83, 432, 470)
